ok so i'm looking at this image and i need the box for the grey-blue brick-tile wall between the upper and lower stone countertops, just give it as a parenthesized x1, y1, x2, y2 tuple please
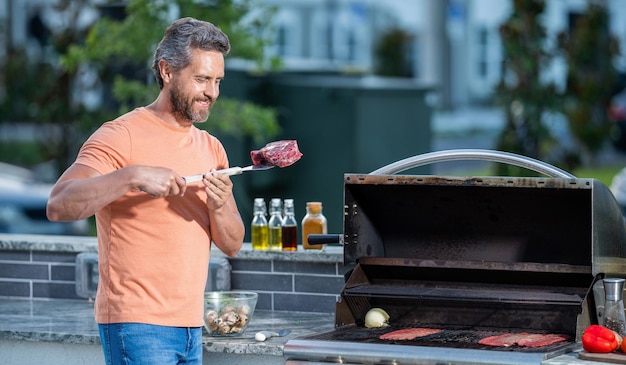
(0, 247, 348, 313)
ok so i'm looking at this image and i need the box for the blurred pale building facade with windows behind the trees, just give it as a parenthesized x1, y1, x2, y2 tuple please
(0, 0, 626, 108)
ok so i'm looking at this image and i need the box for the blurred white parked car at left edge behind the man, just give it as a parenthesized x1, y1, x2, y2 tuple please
(0, 164, 89, 235)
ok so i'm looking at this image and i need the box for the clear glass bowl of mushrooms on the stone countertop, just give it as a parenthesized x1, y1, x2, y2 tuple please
(204, 291, 259, 337)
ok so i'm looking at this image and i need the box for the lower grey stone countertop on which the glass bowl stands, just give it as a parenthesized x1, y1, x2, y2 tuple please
(0, 299, 334, 356)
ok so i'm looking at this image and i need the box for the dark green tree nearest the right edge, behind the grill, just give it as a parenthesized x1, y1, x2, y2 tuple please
(559, 2, 619, 162)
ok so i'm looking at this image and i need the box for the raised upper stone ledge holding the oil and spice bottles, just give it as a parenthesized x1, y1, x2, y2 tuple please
(0, 233, 343, 263)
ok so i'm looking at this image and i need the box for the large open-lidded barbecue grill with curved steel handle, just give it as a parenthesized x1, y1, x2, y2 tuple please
(284, 150, 626, 365)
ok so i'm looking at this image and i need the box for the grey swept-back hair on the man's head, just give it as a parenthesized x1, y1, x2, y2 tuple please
(152, 18, 230, 89)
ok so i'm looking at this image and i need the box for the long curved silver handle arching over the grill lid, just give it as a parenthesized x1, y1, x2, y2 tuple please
(369, 149, 576, 179)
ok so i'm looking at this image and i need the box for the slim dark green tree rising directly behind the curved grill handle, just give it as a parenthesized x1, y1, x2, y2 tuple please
(496, 0, 560, 176)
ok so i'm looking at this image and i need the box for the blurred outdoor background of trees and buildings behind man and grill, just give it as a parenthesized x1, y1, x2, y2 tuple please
(0, 0, 626, 240)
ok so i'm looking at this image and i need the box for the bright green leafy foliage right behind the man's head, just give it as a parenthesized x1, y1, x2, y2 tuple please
(63, 0, 280, 148)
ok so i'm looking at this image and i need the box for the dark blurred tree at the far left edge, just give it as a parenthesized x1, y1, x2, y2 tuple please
(0, 0, 106, 171)
